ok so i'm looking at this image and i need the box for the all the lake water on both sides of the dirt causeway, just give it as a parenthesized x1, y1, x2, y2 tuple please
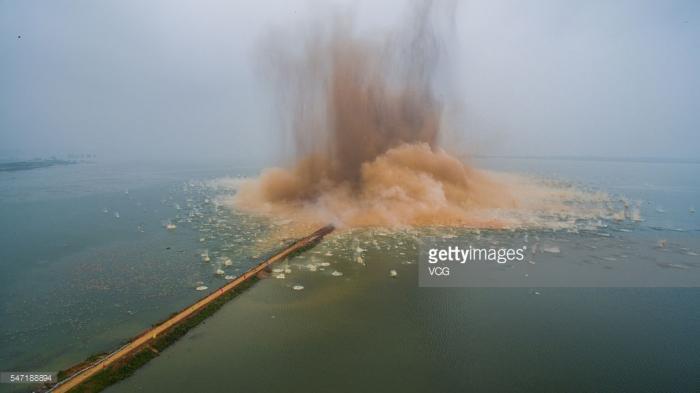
(0, 159, 700, 392)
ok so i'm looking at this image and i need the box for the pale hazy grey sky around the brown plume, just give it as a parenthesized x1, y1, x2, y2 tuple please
(0, 0, 700, 164)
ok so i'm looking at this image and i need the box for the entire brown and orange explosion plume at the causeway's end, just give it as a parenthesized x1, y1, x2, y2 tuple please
(234, 2, 616, 227)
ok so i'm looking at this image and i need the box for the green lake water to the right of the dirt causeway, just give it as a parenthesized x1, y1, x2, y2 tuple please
(110, 160, 700, 392)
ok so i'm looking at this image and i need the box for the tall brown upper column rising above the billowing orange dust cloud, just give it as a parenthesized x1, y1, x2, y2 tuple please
(264, 2, 445, 182)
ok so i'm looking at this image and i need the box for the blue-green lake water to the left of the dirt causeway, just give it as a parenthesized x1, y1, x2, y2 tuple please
(0, 164, 263, 389)
